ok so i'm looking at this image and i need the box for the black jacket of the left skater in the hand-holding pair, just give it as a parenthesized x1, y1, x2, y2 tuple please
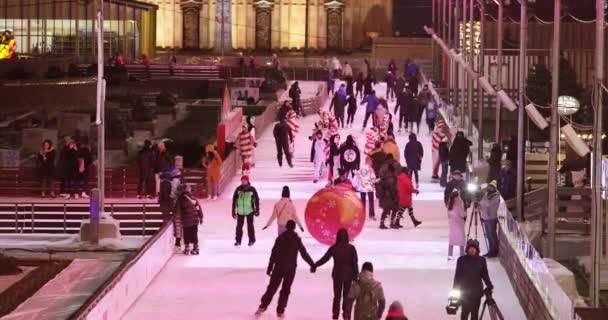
(267, 230, 314, 274)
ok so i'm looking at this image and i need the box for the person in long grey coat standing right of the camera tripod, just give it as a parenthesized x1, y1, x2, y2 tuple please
(479, 180, 500, 258)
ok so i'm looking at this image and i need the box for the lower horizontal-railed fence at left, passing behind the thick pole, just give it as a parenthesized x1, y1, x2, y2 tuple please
(0, 201, 163, 236)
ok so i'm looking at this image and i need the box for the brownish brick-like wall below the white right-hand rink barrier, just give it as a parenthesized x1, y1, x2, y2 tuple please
(498, 227, 553, 320)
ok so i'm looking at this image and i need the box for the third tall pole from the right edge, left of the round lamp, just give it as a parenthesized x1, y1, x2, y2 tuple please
(515, 0, 528, 221)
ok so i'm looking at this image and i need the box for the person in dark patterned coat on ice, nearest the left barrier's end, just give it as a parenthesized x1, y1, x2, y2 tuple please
(175, 184, 203, 255)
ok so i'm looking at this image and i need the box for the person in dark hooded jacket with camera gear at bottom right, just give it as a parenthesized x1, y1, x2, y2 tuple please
(454, 239, 494, 320)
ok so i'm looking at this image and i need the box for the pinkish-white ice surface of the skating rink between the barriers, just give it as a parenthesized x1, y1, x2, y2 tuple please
(125, 83, 525, 320)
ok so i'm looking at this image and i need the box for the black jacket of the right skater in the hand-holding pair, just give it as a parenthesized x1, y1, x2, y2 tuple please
(315, 230, 359, 282)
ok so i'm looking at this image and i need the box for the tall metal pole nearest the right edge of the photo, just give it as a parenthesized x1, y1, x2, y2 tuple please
(589, 0, 605, 308)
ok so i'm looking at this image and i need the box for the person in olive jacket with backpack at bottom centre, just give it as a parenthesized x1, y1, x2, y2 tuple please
(344, 262, 386, 320)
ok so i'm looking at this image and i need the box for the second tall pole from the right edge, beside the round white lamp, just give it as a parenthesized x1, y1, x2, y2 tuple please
(547, 0, 562, 258)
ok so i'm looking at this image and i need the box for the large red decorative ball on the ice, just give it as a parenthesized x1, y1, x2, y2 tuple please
(304, 185, 365, 245)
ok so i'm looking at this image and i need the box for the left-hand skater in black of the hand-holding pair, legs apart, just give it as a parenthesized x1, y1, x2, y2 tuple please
(255, 220, 316, 319)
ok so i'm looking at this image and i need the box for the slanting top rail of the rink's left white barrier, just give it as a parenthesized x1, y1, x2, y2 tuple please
(70, 222, 173, 319)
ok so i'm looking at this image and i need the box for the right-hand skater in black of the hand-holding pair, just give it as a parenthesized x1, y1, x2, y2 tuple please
(313, 228, 359, 320)
